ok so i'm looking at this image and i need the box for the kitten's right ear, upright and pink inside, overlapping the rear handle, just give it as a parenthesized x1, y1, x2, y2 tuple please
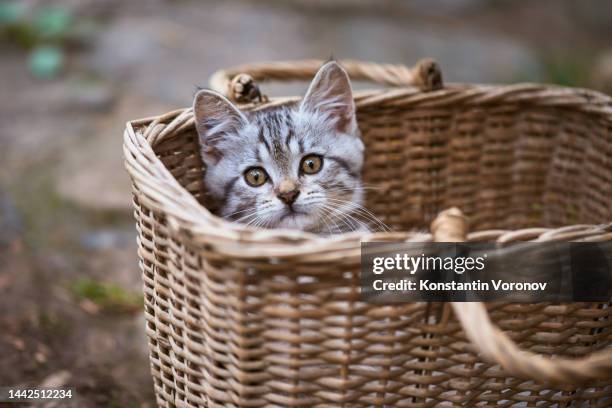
(300, 61, 357, 133)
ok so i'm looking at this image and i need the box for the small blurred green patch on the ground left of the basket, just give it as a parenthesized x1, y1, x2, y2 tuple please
(69, 278, 143, 312)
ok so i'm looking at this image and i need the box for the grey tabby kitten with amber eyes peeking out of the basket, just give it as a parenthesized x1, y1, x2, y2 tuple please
(193, 61, 384, 234)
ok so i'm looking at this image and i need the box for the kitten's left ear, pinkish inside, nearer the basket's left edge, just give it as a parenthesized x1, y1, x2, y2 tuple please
(193, 89, 248, 162)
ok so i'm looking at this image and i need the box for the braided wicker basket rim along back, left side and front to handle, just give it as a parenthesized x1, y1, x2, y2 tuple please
(124, 83, 612, 260)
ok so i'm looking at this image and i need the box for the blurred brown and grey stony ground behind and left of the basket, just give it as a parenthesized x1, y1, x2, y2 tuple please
(0, 0, 612, 407)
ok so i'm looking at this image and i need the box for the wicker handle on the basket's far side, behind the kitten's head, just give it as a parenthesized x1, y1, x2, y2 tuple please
(209, 58, 442, 102)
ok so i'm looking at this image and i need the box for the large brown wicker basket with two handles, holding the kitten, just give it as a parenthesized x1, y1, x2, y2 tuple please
(124, 61, 612, 407)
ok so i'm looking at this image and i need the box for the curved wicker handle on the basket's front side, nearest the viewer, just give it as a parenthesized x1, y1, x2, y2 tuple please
(431, 208, 612, 384)
